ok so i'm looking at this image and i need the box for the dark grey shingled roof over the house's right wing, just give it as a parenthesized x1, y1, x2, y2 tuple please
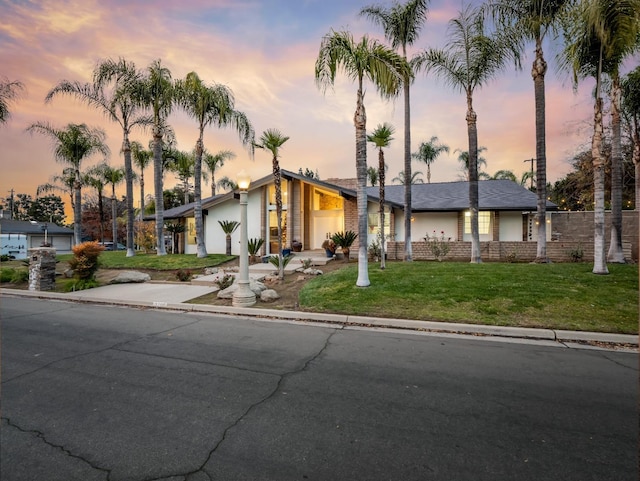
(367, 180, 557, 212)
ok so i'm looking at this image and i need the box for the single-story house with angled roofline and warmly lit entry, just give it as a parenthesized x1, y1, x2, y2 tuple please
(156, 170, 556, 254)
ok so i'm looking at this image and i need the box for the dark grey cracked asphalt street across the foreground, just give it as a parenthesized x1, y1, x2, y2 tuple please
(0, 297, 638, 481)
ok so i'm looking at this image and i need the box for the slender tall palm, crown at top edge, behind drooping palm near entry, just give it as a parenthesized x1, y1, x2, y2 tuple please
(360, 0, 429, 261)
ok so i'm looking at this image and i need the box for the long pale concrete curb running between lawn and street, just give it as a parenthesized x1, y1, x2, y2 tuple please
(0, 288, 639, 351)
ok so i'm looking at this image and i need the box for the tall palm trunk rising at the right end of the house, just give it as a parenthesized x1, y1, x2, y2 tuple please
(531, 37, 549, 263)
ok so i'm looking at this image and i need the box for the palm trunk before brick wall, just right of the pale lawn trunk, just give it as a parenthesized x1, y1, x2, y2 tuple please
(607, 75, 625, 264)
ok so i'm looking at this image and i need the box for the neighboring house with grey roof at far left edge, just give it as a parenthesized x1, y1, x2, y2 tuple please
(0, 218, 73, 259)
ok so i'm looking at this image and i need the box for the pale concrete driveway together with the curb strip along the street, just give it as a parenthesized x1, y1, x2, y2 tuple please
(0, 282, 638, 352)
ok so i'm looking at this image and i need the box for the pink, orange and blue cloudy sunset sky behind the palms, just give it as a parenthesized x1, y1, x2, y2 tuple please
(0, 0, 608, 214)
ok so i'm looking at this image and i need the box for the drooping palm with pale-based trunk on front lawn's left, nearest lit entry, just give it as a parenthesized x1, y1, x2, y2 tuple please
(315, 31, 411, 287)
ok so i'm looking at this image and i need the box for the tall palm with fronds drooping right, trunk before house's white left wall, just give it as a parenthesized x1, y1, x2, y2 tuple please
(176, 72, 255, 257)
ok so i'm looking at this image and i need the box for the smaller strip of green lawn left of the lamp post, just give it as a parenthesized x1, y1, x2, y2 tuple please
(56, 251, 235, 271)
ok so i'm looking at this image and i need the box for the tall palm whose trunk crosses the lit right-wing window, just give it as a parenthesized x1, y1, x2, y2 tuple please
(417, 6, 519, 263)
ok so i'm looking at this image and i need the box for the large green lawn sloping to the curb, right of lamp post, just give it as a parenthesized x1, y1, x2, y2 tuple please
(299, 262, 638, 334)
